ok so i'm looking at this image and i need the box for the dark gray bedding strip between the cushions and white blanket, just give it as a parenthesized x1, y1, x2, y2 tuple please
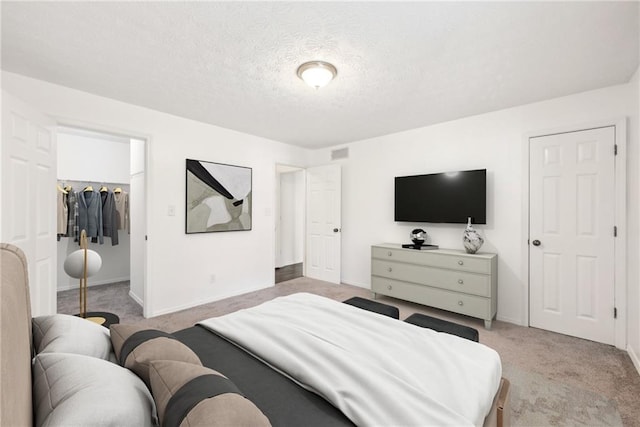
(173, 326, 354, 427)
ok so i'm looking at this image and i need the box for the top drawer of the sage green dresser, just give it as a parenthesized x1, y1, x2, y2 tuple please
(371, 246, 491, 274)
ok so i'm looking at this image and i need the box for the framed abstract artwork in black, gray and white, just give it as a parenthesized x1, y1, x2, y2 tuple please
(185, 159, 252, 234)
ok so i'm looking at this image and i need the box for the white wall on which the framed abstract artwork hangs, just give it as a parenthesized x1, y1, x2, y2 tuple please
(2, 72, 307, 316)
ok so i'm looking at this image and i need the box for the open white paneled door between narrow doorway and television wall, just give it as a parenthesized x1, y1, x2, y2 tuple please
(305, 165, 342, 283)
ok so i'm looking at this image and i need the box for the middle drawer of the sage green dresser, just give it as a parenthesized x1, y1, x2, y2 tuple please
(371, 259, 491, 297)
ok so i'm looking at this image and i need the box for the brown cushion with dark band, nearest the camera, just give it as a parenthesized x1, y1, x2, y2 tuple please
(149, 360, 271, 427)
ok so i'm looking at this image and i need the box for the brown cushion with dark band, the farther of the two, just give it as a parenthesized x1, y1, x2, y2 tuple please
(111, 324, 202, 386)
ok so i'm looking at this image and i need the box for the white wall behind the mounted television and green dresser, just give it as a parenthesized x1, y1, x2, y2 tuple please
(314, 85, 638, 324)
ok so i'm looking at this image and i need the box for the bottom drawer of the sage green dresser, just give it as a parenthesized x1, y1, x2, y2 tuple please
(371, 277, 493, 320)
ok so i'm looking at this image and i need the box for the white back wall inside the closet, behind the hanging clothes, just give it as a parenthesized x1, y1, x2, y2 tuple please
(57, 130, 130, 290)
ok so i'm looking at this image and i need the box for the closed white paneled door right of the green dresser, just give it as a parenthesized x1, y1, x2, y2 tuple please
(529, 126, 615, 344)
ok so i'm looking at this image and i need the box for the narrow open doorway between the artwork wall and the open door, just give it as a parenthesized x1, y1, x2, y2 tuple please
(275, 165, 305, 283)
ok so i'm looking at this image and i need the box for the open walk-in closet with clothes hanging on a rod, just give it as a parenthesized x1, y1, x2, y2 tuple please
(52, 127, 145, 314)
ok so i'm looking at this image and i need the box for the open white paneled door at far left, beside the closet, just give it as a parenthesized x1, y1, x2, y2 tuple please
(0, 91, 57, 316)
